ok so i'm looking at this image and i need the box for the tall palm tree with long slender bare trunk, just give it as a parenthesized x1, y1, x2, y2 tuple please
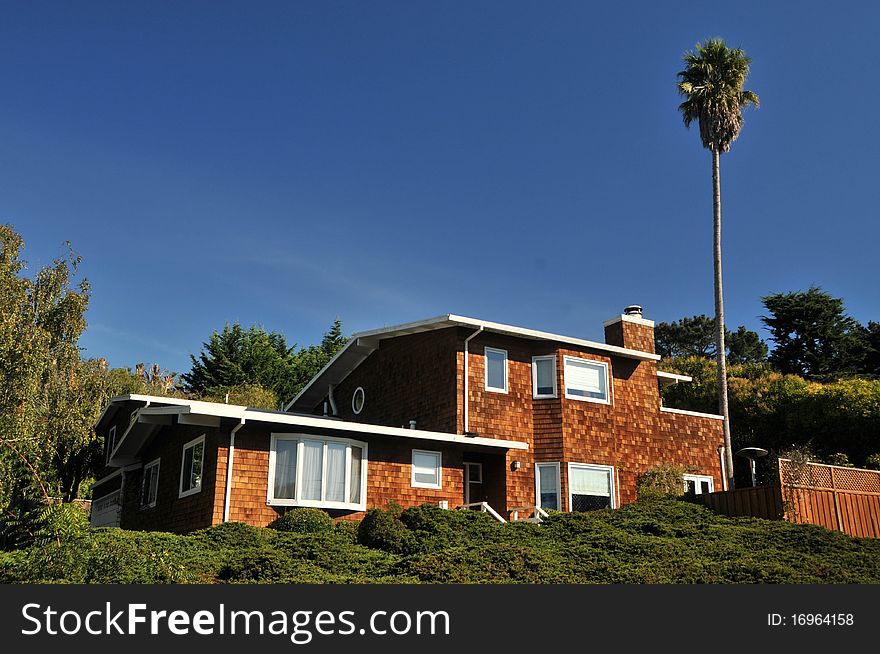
(678, 39, 759, 488)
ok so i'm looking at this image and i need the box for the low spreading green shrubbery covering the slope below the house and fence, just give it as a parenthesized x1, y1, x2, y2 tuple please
(0, 498, 880, 584)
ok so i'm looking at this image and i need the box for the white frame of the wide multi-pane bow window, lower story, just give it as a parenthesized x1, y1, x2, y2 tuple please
(266, 433, 368, 511)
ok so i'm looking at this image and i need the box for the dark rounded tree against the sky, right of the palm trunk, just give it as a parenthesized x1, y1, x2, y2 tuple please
(761, 286, 869, 380)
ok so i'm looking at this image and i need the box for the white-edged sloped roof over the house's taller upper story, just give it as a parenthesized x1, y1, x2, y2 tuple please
(284, 313, 660, 411)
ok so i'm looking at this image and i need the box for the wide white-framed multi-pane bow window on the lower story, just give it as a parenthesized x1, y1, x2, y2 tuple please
(266, 434, 367, 511)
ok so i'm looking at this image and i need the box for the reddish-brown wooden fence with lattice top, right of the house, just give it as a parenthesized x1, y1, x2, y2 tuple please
(697, 459, 880, 538)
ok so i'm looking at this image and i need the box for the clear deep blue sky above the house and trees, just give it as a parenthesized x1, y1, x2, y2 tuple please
(0, 1, 880, 372)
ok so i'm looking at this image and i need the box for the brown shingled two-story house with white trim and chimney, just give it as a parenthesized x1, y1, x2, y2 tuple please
(92, 307, 724, 531)
